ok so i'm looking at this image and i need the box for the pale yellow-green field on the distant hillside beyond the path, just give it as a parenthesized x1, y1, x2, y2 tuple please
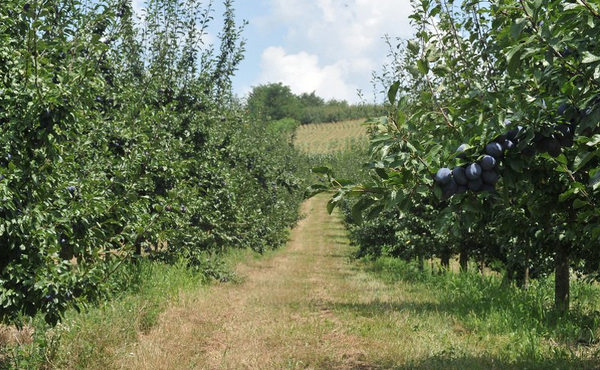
(294, 119, 368, 154)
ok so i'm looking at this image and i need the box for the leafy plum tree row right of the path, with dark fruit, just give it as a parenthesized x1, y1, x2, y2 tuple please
(322, 0, 600, 312)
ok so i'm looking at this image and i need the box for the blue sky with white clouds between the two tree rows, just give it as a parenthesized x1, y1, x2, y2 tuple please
(134, 0, 413, 102)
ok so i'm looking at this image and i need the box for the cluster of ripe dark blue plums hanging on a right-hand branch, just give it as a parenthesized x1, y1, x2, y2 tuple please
(434, 106, 575, 199)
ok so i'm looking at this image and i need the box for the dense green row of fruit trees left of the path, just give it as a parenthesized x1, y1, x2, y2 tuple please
(0, 0, 303, 324)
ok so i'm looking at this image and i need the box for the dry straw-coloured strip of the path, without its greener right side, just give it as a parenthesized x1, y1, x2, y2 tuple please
(116, 197, 380, 369)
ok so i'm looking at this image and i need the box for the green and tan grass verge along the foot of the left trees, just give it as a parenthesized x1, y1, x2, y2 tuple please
(0, 250, 255, 370)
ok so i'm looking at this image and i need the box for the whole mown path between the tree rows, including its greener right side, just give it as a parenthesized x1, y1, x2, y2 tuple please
(112, 197, 552, 370)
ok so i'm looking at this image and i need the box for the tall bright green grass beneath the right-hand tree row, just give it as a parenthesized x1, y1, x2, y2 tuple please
(366, 257, 600, 368)
